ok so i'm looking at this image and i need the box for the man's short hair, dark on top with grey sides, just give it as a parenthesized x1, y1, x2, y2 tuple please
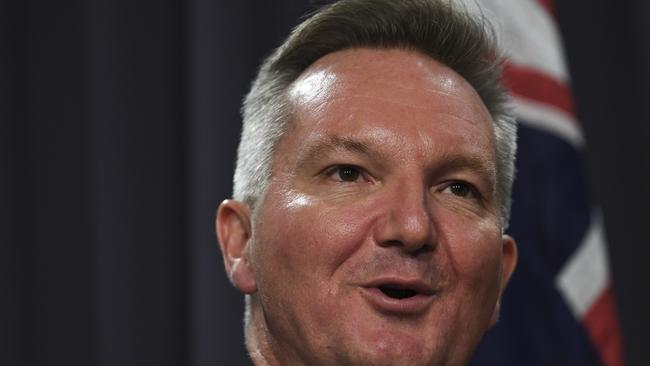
(233, 0, 517, 229)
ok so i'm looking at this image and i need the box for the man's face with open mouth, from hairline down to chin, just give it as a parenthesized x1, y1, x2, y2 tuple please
(225, 49, 516, 365)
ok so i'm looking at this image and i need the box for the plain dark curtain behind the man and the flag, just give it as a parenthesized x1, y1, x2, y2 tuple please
(0, 0, 650, 366)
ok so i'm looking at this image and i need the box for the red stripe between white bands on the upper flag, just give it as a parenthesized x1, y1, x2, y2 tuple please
(503, 63, 575, 117)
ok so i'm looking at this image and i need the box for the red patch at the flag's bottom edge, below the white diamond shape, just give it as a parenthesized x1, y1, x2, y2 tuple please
(582, 287, 623, 366)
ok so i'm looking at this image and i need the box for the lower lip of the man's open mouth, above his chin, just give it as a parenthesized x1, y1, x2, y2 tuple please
(361, 287, 434, 315)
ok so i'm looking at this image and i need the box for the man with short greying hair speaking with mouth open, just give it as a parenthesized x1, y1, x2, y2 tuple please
(217, 0, 517, 365)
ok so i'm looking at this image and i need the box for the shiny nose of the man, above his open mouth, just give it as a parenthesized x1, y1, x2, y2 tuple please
(375, 179, 437, 255)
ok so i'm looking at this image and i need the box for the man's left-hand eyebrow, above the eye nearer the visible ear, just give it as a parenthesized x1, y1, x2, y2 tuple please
(298, 136, 388, 167)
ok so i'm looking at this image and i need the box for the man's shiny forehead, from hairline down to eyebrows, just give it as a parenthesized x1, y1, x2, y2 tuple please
(280, 48, 494, 162)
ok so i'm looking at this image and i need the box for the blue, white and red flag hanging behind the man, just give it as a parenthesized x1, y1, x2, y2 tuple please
(464, 0, 623, 366)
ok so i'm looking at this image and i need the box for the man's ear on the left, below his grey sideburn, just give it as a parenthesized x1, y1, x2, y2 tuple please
(216, 200, 257, 294)
